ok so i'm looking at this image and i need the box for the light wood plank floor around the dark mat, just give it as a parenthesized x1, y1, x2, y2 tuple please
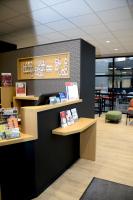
(35, 115, 133, 200)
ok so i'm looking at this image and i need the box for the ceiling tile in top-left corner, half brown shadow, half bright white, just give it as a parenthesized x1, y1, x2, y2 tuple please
(0, 0, 47, 13)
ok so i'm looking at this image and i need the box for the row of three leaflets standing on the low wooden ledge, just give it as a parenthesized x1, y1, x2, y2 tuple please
(60, 108, 78, 128)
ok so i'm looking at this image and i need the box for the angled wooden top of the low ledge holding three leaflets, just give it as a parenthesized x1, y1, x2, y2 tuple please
(52, 118, 96, 136)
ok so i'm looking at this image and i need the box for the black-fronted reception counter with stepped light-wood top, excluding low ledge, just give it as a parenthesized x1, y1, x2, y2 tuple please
(0, 100, 88, 200)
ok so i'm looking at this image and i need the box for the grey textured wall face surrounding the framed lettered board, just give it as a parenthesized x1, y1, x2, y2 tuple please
(0, 39, 80, 96)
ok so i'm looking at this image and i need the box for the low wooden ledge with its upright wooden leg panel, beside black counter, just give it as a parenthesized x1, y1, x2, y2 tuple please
(52, 118, 96, 161)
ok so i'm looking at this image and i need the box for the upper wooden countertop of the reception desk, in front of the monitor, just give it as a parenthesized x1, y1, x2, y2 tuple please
(21, 99, 82, 112)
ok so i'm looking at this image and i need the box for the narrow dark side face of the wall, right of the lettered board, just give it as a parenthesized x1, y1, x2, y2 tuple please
(80, 40, 95, 117)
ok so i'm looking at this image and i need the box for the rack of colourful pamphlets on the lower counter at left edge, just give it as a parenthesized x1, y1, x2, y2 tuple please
(0, 108, 20, 140)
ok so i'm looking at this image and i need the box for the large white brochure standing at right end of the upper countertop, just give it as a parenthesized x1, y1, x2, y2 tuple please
(65, 82, 79, 100)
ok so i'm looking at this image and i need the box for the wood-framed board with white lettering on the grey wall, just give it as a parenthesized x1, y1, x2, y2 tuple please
(17, 53, 70, 80)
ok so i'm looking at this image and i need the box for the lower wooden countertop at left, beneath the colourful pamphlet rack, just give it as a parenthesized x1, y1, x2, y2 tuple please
(0, 133, 36, 146)
